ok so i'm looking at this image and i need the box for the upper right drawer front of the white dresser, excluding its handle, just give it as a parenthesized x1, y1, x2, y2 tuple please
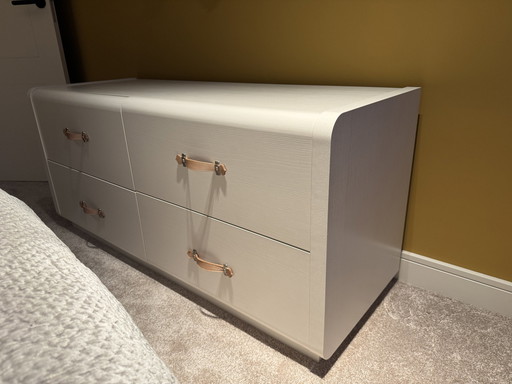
(123, 110, 312, 250)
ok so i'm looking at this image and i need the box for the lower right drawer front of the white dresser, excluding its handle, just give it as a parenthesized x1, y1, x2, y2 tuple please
(137, 194, 310, 342)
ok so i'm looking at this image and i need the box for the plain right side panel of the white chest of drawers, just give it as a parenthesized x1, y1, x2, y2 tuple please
(324, 89, 420, 357)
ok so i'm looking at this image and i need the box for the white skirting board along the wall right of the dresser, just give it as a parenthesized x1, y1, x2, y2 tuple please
(398, 251, 512, 317)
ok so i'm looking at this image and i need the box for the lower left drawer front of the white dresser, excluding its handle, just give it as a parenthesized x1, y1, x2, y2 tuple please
(49, 162, 145, 259)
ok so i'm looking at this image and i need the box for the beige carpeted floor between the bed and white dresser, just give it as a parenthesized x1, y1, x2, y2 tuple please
(0, 182, 512, 384)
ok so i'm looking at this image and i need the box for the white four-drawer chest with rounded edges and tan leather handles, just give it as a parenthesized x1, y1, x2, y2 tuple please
(31, 80, 420, 358)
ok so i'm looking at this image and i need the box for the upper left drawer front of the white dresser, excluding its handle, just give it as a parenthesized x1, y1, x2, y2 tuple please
(32, 90, 133, 188)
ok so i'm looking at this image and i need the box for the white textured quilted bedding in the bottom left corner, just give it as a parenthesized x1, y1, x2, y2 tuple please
(0, 189, 178, 384)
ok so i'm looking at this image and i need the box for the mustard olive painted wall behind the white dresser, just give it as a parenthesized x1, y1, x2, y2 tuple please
(56, 0, 512, 281)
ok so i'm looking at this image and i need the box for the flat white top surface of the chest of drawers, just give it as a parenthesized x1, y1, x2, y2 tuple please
(42, 79, 414, 113)
